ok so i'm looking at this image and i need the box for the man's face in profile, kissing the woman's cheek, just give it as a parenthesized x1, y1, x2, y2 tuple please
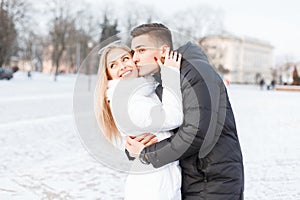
(131, 35, 162, 76)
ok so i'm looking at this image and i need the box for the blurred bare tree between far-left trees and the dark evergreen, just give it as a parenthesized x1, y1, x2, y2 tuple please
(49, 0, 95, 80)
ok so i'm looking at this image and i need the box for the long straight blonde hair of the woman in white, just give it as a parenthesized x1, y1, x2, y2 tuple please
(95, 44, 131, 141)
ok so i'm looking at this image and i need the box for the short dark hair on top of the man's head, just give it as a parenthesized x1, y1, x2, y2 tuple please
(131, 23, 173, 49)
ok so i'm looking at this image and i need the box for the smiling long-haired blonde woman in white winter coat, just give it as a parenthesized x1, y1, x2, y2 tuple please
(96, 44, 183, 200)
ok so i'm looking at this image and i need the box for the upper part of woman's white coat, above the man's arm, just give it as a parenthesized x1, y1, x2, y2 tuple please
(106, 66, 183, 143)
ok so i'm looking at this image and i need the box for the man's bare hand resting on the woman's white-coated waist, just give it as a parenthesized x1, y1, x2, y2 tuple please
(126, 133, 158, 158)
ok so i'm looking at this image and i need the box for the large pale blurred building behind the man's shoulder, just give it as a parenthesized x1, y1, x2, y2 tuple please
(199, 34, 273, 83)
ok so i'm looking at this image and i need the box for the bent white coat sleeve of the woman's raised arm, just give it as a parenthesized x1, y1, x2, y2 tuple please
(129, 66, 183, 135)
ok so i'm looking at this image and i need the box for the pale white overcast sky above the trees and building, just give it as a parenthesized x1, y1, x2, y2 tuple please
(31, 0, 300, 63)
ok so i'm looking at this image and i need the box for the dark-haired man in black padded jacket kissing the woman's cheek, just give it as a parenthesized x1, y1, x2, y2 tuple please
(126, 23, 244, 200)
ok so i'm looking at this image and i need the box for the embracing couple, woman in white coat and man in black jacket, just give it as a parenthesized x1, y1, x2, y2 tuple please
(97, 23, 244, 200)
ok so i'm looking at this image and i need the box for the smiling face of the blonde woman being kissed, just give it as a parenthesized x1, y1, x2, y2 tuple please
(106, 48, 138, 79)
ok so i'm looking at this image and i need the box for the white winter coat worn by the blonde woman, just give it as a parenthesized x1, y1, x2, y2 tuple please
(107, 66, 183, 200)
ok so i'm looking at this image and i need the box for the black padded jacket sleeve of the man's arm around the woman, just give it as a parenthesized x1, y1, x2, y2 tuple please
(141, 63, 211, 168)
